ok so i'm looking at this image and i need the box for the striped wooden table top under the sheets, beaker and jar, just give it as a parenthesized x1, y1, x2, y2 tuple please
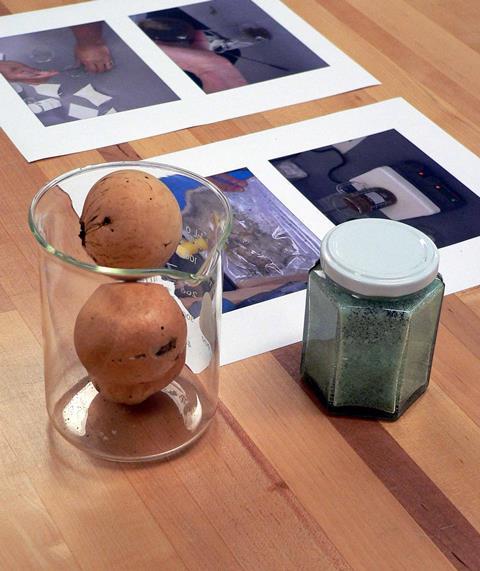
(0, 0, 480, 571)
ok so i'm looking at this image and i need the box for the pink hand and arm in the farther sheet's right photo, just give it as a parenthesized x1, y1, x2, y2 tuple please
(157, 30, 247, 93)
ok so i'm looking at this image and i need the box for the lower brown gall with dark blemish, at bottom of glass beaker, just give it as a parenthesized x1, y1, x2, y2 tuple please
(74, 282, 187, 404)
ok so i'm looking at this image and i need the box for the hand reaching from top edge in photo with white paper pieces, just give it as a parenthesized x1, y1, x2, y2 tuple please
(72, 22, 113, 73)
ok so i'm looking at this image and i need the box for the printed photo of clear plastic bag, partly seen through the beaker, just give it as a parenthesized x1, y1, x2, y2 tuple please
(162, 168, 320, 313)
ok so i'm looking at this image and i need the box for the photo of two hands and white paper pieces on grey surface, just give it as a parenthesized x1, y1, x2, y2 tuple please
(0, 22, 179, 127)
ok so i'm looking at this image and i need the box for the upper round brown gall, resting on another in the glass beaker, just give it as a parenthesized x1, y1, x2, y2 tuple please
(80, 169, 182, 268)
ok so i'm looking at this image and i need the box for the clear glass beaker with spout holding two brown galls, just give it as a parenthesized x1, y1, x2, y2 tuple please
(29, 162, 231, 462)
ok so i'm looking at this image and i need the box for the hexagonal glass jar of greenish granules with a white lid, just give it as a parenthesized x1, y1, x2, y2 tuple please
(301, 219, 444, 419)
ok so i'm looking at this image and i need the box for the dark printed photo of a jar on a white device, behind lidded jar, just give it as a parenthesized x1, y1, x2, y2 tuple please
(270, 129, 480, 248)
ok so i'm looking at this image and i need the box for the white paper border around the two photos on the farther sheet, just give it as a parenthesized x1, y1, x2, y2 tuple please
(0, 0, 379, 161)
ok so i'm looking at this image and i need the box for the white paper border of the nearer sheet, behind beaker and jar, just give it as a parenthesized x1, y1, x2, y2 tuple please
(142, 98, 480, 364)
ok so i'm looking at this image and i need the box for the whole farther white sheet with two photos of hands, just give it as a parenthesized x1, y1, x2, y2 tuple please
(0, 0, 378, 161)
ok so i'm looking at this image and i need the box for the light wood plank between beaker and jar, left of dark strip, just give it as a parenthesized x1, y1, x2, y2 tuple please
(221, 355, 450, 569)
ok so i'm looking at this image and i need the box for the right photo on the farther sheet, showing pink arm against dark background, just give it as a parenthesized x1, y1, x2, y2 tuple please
(132, 0, 328, 93)
